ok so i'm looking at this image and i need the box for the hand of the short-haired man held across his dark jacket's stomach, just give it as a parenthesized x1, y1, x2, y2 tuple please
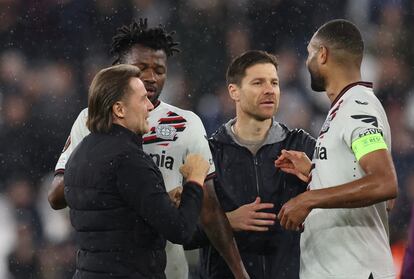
(226, 197, 276, 232)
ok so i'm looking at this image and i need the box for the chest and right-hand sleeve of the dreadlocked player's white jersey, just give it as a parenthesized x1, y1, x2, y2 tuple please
(143, 102, 215, 191)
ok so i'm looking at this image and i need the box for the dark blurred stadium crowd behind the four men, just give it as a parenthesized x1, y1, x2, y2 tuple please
(0, 0, 414, 279)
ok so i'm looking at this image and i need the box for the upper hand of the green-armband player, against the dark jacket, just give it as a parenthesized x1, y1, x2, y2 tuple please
(275, 149, 312, 182)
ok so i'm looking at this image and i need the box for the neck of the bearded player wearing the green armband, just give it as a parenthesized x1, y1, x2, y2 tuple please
(326, 68, 361, 103)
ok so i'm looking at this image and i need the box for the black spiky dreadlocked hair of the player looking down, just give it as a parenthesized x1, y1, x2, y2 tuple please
(111, 18, 180, 64)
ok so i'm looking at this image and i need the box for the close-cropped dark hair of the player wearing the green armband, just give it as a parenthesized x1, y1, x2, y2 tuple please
(315, 19, 364, 59)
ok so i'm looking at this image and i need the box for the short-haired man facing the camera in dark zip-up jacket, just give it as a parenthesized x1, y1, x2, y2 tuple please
(192, 51, 315, 279)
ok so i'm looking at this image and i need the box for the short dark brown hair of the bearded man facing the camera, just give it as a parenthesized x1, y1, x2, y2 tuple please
(226, 50, 278, 85)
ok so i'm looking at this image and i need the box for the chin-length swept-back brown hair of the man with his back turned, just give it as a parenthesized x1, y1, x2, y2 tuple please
(86, 64, 140, 133)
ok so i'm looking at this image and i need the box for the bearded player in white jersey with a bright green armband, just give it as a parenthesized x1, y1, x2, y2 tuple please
(276, 20, 397, 279)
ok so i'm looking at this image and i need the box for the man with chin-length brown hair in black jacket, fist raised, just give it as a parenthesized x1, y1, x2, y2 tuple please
(64, 64, 209, 279)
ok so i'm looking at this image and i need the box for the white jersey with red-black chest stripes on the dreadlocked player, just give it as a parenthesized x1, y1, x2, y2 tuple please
(55, 102, 215, 279)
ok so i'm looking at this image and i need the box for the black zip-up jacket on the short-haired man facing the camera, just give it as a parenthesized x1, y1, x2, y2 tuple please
(201, 120, 315, 279)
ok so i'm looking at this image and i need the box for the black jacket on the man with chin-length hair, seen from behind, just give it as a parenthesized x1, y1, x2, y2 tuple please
(64, 124, 203, 279)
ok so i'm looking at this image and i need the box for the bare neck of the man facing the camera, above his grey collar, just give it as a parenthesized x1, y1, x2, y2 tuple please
(233, 115, 272, 141)
